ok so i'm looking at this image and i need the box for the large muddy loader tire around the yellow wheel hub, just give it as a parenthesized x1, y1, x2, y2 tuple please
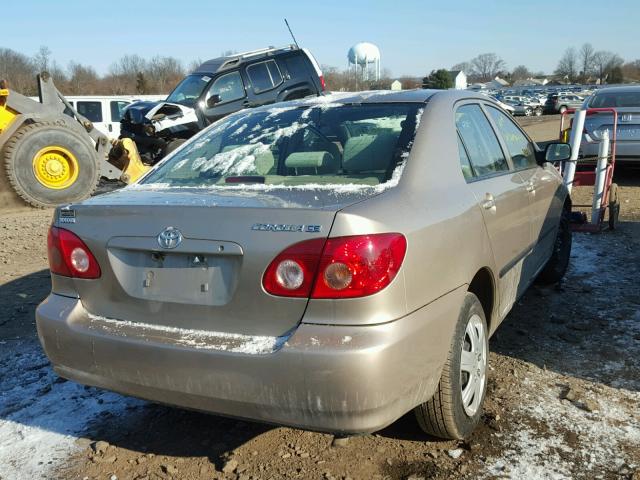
(3, 123, 100, 208)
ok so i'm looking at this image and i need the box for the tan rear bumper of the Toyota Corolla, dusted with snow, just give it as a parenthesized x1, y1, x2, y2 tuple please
(36, 287, 465, 433)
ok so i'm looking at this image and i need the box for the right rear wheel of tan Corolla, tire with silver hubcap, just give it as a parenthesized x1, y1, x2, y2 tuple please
(415, 292, 489, 439)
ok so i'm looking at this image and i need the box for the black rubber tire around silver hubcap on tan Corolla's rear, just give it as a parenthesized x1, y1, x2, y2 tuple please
(414, 292, 489, 439)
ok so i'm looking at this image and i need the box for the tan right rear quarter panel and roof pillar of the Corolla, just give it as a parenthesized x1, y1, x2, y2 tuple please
(305, 92, 495, 330)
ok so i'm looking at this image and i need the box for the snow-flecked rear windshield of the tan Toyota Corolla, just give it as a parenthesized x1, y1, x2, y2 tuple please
(140, 103, 423, 188)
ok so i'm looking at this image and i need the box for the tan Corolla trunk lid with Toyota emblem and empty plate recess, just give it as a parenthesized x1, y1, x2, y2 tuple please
(58, 189, 375, 336)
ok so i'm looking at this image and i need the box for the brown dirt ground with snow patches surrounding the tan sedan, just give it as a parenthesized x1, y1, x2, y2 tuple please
(0, 117, 640, 480)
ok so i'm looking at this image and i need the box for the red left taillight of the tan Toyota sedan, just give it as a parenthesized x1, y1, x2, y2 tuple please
(47, 227, 101, 279)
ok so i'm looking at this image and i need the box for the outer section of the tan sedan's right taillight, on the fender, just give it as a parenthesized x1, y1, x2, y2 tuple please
(311, 233, 407, 298)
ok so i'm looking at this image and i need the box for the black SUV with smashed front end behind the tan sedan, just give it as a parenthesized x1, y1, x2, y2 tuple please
(120, 45, 324, 164)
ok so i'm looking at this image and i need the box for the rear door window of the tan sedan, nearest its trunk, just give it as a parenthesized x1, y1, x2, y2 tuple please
(456, 104, 509, 177)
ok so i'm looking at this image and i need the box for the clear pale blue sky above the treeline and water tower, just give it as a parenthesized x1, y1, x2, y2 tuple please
(0, 0, 640, 76)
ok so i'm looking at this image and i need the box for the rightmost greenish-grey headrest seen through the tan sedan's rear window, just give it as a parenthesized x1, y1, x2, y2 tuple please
(342, 133, 398, 172)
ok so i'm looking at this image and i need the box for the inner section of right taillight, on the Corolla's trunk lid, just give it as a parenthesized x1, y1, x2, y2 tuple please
(262, 238, 325, 298)
